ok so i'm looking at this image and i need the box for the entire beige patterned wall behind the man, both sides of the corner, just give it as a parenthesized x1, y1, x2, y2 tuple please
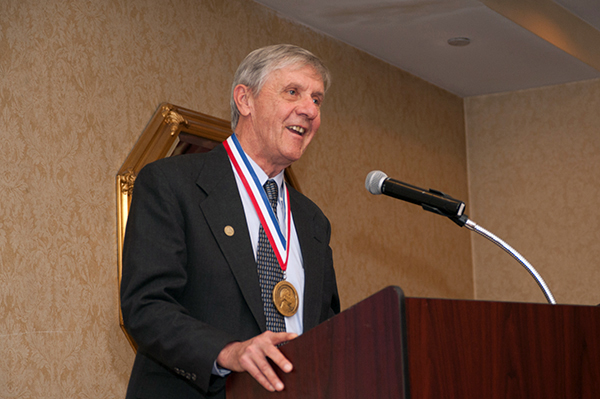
(5, 0, 600, 399)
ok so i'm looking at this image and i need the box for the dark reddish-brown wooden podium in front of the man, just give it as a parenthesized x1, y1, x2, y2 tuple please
(227, 287, 600, 399)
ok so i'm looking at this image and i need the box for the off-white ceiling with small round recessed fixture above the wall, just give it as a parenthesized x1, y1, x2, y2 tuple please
(255, 0, 600, 97)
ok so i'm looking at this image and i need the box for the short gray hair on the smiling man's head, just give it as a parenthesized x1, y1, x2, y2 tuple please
(229, 44, 331, 131)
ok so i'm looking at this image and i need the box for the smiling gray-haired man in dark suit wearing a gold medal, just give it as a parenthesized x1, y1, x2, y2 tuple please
(121, 45, 340, 399)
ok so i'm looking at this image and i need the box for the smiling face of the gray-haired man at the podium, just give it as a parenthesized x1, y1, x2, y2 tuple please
(244, 65, 324, 170)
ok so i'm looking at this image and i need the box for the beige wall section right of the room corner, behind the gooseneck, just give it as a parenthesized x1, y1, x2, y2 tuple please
(465, 80, 600, 305)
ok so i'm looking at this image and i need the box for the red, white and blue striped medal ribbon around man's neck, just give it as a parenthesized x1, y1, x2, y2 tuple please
(223, 133, 291, 275)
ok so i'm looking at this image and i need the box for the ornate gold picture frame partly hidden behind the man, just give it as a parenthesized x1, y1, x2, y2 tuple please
(116, 103, 299, 350)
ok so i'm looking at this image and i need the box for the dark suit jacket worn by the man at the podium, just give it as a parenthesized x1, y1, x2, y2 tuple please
(121, 145, 340, 399)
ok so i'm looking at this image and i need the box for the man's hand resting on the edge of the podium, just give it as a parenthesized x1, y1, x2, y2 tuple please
(217, 331, 298, 392)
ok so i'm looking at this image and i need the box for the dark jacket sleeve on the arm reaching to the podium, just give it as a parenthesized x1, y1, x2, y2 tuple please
(121, 164, 235, 392)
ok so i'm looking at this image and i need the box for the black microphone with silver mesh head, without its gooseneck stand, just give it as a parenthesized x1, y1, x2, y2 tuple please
(365, 170, 465, 219)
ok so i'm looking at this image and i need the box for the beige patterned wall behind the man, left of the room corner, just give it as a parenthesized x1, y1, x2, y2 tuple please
(0, 0, 474, 399)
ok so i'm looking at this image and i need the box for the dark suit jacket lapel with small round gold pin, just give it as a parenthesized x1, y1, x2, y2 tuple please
(196, 145, 266, 331)
